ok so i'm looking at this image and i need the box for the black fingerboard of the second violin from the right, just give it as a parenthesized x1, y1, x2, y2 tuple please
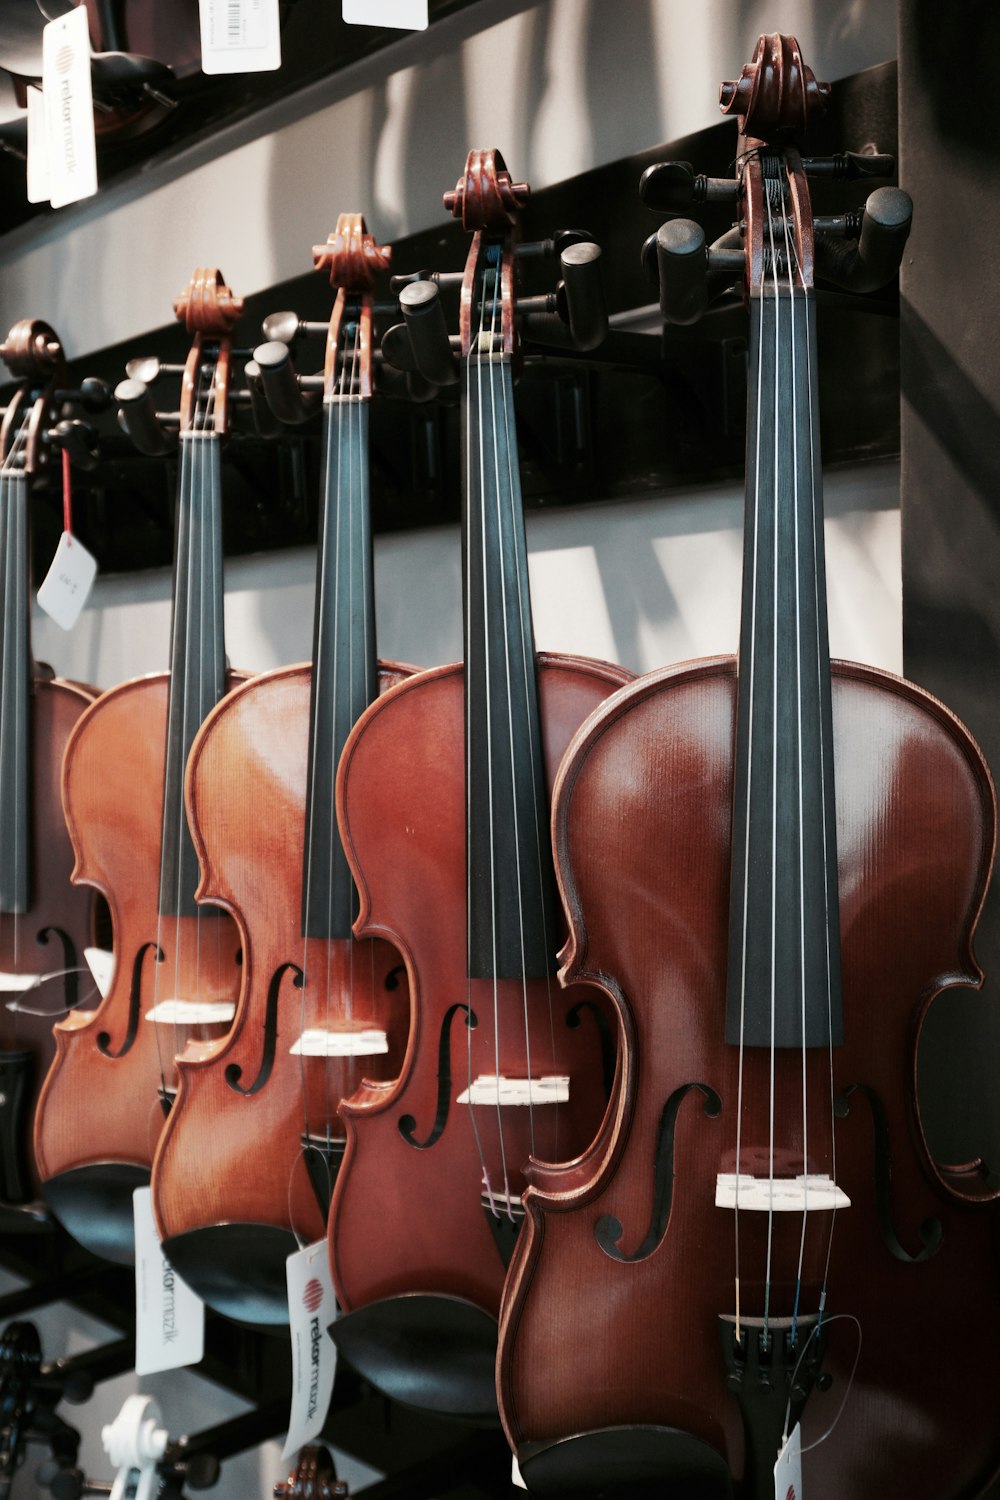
(465, 351, 556, 978)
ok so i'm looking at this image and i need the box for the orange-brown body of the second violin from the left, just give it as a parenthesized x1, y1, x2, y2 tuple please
(34, 672, 240, 1262)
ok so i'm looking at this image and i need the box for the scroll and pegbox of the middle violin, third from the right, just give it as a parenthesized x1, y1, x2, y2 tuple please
(253, 213, 393, 426)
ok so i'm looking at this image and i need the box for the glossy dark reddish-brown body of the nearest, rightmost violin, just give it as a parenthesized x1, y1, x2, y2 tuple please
(498, 659, 1000, 1500)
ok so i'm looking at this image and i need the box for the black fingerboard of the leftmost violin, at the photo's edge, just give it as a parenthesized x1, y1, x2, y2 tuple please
(0, 473, 31, 914)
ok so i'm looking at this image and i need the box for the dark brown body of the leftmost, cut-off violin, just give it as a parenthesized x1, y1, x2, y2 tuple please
(0, 677, 94, 1214)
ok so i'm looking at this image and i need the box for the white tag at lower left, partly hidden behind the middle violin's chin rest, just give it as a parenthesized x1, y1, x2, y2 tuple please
(132, 1188, 205, 1376)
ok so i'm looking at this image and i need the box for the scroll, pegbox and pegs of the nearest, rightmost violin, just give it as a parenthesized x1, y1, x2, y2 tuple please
(639, 33, 913, 326)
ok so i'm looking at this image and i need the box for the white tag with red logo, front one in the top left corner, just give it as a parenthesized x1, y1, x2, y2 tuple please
(42, 5, 97, 209)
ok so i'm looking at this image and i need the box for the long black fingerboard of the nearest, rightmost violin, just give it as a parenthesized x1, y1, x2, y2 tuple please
(726, 285, 843, 1047)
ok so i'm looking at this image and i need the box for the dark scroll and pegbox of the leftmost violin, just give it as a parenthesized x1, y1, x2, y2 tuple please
(0, 318, 111, 476)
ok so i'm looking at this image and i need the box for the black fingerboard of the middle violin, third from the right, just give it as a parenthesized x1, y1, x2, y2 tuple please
(301, 398, 378, 938)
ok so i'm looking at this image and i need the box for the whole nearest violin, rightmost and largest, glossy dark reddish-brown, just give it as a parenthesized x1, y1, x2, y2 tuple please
(498, 36, 1000, 1500)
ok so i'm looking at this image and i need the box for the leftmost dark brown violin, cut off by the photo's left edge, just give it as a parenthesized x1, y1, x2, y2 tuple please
(0, 318, 109, 1232)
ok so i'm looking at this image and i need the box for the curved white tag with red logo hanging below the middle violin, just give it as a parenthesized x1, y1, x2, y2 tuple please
(282, 1239, 337, 1460)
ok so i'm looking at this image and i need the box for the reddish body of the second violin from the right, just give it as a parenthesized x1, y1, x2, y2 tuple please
(330, 653, 630, 1317)
